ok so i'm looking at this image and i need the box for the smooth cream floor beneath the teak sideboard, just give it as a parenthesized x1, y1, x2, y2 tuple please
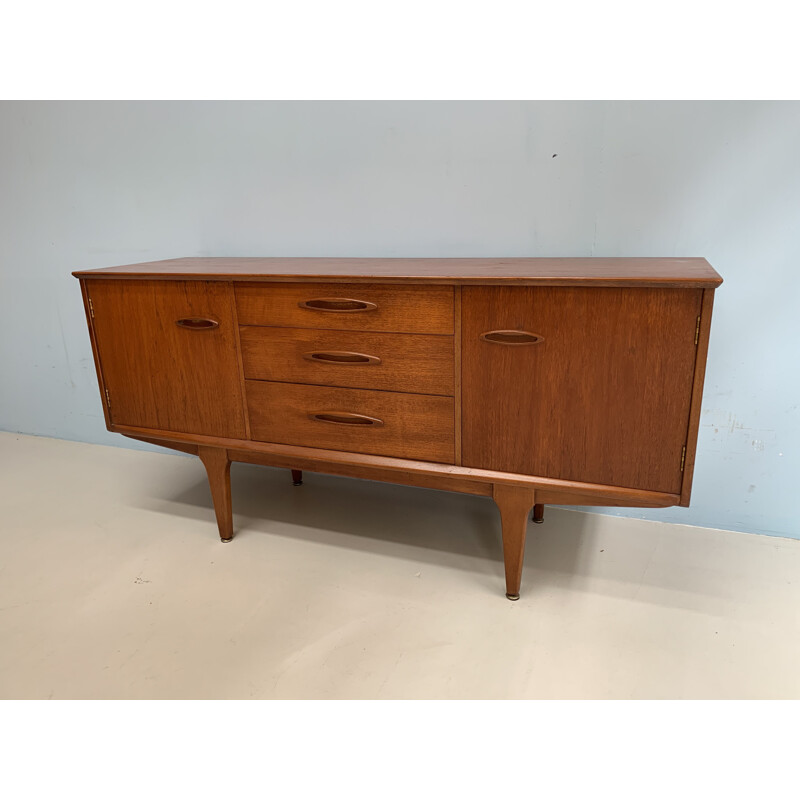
(0, 433, 800, 699)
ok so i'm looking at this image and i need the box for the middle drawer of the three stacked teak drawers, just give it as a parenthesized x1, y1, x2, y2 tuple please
(240, 326, 454, 395)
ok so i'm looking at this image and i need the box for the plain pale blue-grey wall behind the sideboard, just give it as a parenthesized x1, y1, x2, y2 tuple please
(0, 102, 800, 537)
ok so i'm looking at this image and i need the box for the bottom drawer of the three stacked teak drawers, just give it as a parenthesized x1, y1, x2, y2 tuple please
(245, 381, 455, 464)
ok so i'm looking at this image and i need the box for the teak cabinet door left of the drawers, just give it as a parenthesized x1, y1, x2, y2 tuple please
(87, 279, 245, 438)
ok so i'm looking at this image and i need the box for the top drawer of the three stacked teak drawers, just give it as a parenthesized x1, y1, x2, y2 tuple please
(236, 283, 453, 335)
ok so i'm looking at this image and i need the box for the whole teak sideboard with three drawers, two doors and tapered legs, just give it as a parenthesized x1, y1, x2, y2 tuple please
(74, 258, 722, 600)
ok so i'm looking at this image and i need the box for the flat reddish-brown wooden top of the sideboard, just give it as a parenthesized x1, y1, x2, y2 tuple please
(72, 258, 722, 289)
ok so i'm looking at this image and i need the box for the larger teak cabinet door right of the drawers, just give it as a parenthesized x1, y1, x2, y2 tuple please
(462, 287, 702, 493)
